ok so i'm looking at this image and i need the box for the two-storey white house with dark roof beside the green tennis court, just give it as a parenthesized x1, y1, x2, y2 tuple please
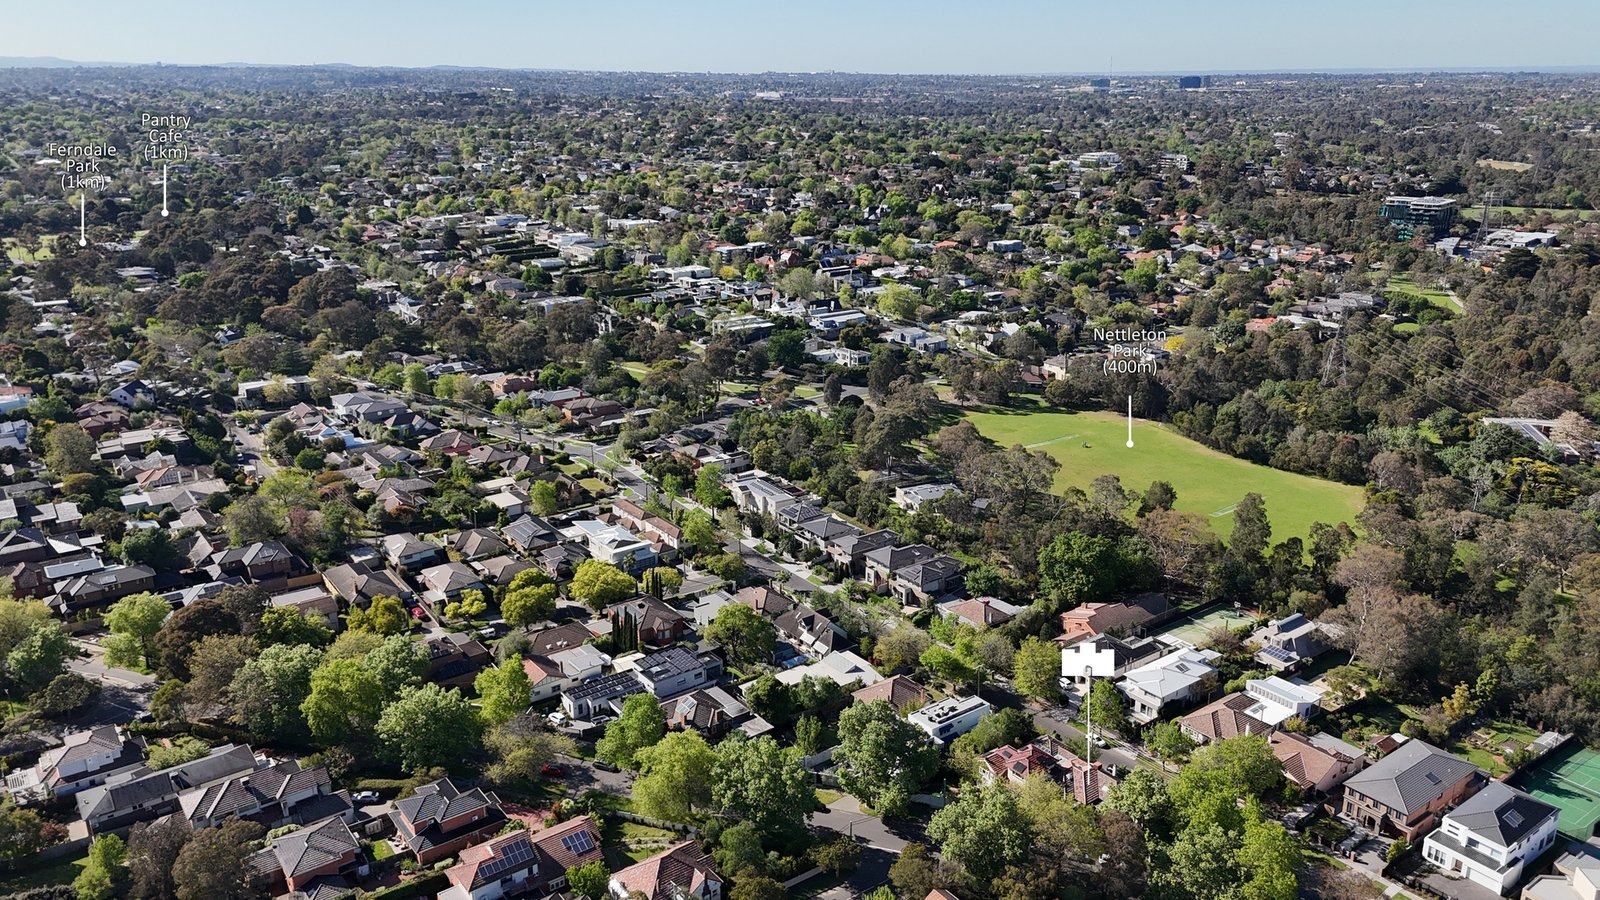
(1422, 781, 1560, 894)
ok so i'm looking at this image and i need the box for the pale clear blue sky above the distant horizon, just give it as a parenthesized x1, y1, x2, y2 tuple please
(9, 0, 1600, 74)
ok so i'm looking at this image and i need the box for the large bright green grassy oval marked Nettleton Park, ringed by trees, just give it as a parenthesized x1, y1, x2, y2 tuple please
(966, 408, 1362, 540)
